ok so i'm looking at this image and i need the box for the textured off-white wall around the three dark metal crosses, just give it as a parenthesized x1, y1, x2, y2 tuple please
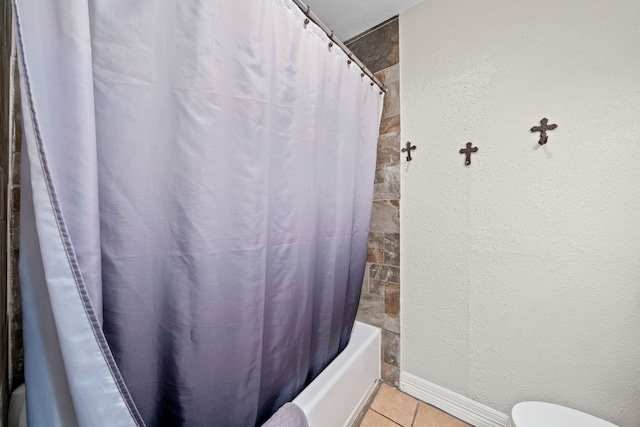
(400, 0, 640, 427)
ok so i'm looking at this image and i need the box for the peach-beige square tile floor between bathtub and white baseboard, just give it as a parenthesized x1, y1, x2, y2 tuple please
(352, 383, 469, 427)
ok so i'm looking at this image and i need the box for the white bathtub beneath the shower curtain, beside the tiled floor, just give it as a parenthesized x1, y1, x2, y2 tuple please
(293, 322, 381, 427)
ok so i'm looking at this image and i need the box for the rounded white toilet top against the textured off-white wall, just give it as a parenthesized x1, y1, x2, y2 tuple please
(507, 402, 618, 427)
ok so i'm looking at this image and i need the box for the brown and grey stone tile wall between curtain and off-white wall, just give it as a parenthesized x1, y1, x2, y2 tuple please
(346, 18, 401, 386)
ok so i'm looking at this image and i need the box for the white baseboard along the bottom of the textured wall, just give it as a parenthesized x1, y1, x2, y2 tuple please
(400, 371, 509, 427)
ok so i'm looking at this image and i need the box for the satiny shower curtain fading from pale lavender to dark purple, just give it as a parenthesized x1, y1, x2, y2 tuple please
(14, 0, 383, 427)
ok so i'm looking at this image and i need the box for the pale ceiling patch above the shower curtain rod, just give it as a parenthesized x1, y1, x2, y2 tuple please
(302, 0, 421, 41)
